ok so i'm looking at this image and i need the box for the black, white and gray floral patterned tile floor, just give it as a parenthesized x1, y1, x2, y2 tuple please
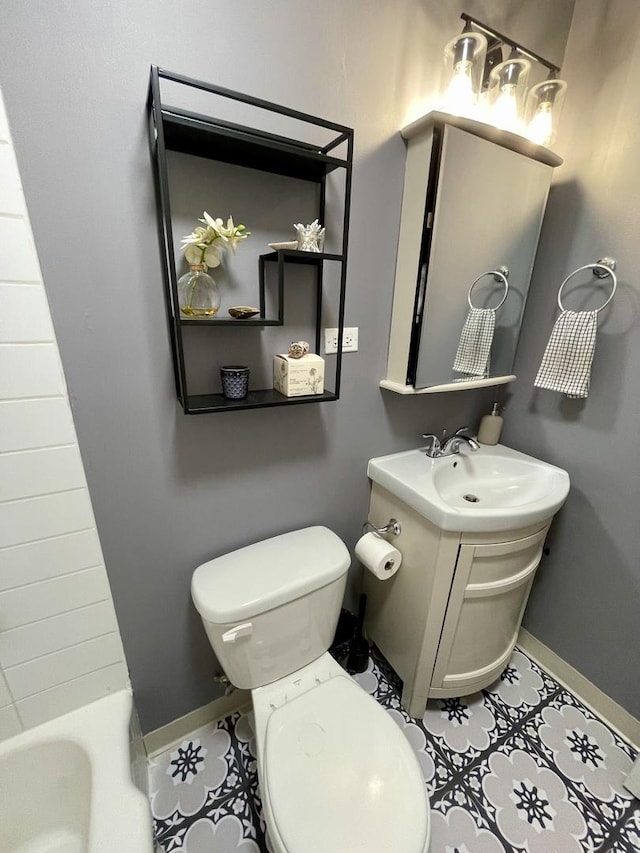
(149, 650, 640, 853)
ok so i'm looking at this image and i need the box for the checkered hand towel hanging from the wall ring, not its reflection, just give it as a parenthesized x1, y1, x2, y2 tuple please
(533, 311, 598, 398)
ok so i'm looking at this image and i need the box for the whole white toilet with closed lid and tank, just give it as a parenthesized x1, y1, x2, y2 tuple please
(191, 527, 430, 853)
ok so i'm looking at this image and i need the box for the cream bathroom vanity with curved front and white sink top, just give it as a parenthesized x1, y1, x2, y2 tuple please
(364, 445, 569, 717)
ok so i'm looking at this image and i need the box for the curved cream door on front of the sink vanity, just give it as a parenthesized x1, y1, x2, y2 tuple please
(429, 527, 548, 697)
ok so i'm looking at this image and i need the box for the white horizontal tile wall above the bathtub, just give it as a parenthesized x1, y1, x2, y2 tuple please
(0, 88, 129, 740)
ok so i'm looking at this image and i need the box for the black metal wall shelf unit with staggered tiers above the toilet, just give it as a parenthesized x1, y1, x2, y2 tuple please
(148, 66, 353, 414)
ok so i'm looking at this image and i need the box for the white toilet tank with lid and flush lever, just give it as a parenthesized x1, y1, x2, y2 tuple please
(191, 527, 351, 689)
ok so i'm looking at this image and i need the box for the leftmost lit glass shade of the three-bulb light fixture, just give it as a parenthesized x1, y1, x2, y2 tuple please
(441, 32, 487, 118)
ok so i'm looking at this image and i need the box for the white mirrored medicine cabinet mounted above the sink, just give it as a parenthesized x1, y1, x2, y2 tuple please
(380, 112, 562, 394)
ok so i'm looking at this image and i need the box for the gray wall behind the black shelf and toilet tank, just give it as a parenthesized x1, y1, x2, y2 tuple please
(0, 0, 573, 730)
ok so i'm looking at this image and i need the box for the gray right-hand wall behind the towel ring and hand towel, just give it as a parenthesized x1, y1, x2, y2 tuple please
(504, 0, 640, 717)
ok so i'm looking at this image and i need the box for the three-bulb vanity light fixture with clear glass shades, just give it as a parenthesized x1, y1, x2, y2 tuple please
(441, 12, 567, 146)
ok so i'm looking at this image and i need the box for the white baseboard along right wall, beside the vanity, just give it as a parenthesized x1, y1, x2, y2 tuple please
(518, 628, 640, 749)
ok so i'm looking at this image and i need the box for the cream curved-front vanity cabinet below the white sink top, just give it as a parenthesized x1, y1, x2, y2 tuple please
(364, 483, 551, 717)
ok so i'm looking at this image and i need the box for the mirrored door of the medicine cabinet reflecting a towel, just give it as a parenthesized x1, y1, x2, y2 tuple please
(416, 126, 552, 388)
